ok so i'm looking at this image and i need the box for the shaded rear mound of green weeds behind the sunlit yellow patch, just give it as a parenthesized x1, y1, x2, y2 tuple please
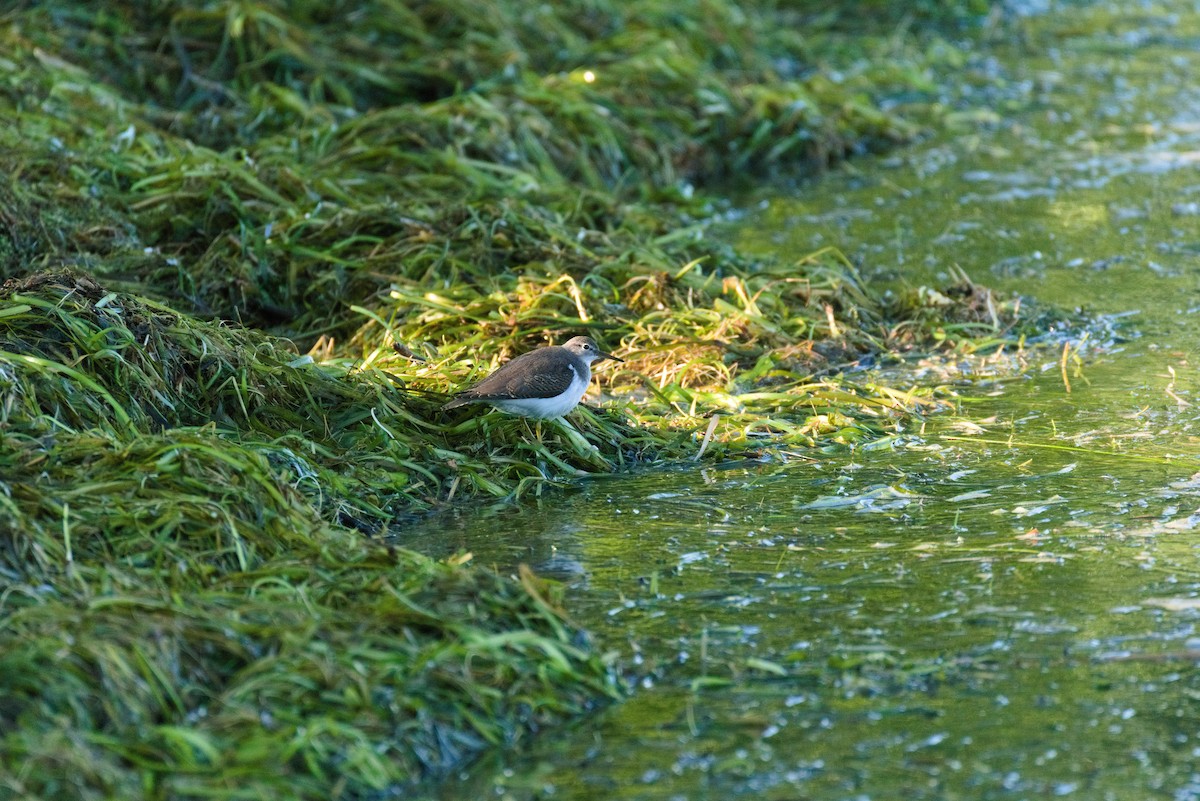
(0, 2, 926, 336)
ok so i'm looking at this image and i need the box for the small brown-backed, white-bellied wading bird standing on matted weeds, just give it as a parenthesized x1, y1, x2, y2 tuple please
(442, 337, 624, 420)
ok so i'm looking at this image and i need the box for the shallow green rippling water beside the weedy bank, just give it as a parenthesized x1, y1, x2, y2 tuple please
(407, 2, 1200, 800)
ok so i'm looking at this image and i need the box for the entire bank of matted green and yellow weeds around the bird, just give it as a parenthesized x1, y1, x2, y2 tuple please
(0, 0, 1080, 799)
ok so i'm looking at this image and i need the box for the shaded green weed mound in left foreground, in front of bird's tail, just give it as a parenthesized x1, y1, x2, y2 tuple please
(0, 276, 616, 799)
